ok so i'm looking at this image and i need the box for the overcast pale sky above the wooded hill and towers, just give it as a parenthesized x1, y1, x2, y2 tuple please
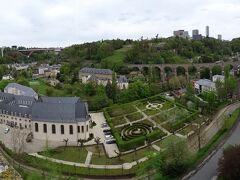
(0, 0, 240, 47)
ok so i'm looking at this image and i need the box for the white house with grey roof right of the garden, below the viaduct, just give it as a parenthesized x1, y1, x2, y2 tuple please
(194, 79, 216, 93)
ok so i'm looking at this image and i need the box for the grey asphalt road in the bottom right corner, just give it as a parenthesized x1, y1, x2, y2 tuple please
(190, 116, 240, 180)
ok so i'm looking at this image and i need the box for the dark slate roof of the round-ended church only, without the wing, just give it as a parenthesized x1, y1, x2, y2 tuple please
(32, 97, 89, 123)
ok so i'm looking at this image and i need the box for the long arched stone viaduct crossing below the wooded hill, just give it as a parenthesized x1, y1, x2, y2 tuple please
(128, 61, 240, 81)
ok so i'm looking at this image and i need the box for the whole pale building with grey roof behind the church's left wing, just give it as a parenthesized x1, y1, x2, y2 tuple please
(4, 83, 38, 99)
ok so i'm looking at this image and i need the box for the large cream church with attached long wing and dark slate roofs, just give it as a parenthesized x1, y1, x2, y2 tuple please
(0, 92, 92, 143)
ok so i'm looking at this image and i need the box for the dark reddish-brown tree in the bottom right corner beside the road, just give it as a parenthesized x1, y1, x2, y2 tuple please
(218, 145, 240, 180)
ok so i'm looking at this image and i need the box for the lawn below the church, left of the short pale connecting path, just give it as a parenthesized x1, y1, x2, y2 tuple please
(39, 147, 88, 163)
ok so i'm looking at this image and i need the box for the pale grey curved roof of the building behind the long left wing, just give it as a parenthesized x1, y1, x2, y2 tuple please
(4, 83, 38, 97)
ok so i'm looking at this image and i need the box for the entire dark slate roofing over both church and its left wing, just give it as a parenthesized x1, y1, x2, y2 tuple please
(0, 92, 90, 123)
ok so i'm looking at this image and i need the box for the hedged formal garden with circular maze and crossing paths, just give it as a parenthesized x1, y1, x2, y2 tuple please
(104, 95, 197, 151)
